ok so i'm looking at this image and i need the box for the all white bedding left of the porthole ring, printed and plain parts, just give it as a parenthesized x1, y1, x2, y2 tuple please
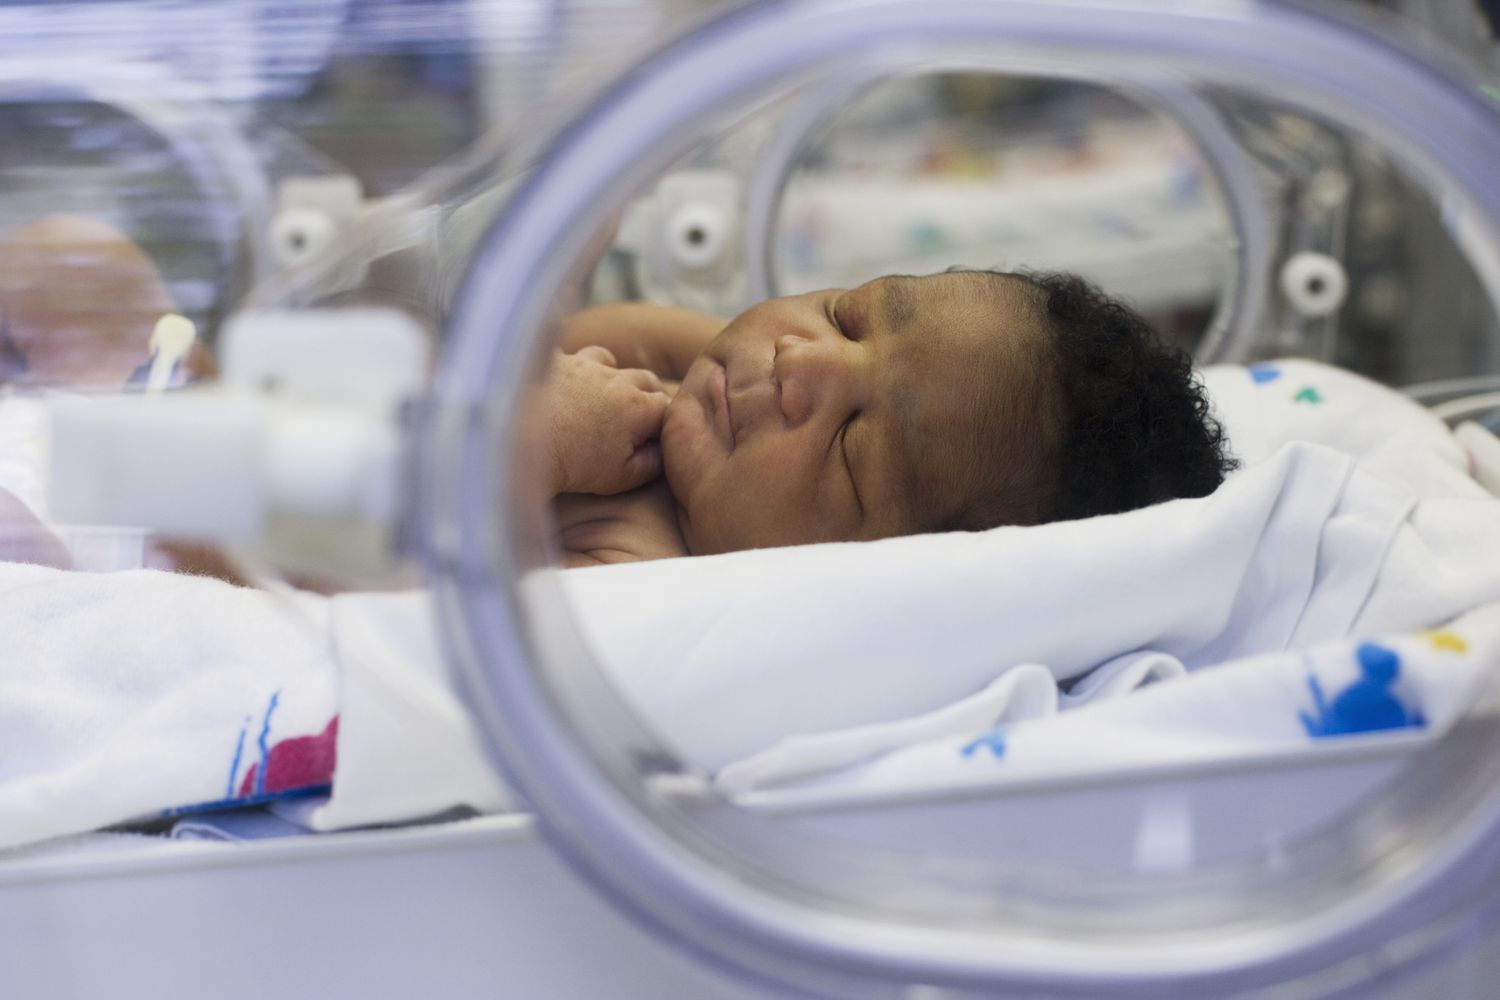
(0, 562, 507, 847)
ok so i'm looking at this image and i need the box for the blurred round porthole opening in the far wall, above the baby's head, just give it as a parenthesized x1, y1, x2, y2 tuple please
(746, 71, 1254, 363)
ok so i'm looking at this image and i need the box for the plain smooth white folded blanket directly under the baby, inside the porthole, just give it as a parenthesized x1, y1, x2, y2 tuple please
(566, 444, 1428, 769)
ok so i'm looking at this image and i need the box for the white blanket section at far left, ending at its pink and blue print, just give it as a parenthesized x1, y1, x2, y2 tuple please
(0, 564, 339, 846)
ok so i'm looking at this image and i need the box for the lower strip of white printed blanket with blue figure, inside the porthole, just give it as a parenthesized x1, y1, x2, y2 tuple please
(717, 604, 1500, 793)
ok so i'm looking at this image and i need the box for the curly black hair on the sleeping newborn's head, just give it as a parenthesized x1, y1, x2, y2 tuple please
(939, 271, 1238, 531)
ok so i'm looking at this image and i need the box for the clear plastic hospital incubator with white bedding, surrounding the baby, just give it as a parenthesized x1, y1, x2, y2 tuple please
(0, 0, 1500, 999)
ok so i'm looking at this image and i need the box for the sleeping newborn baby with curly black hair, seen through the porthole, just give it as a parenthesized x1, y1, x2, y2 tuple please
(546, 271, 1233, 565)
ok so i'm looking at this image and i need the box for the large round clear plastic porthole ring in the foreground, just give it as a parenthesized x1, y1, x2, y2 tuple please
(422, 0, 1500, 996)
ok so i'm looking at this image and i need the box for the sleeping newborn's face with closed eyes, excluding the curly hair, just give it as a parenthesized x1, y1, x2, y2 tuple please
(662, 274, 1035, 555)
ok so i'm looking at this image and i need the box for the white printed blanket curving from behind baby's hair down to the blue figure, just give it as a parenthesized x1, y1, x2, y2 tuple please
(696, 361, 1500, 792)
